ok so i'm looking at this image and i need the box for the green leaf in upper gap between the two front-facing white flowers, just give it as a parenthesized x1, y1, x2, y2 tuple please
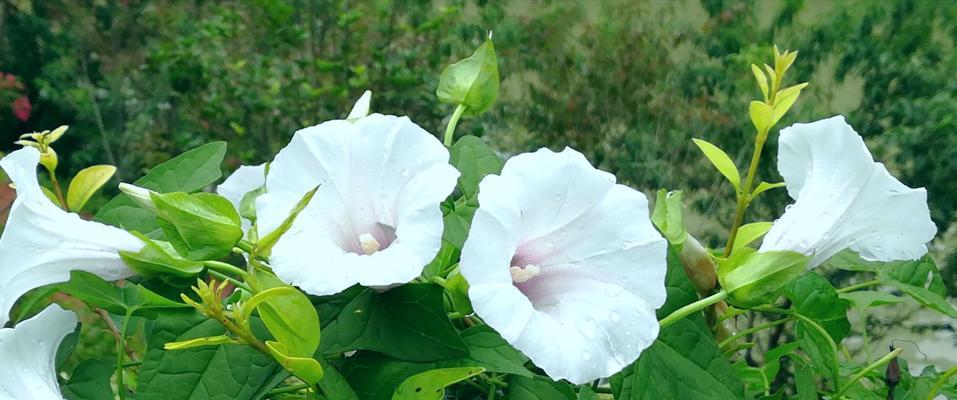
(449, 135, 505, 206)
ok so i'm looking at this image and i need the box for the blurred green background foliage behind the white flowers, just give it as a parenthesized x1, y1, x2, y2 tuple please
(0, 0, 957, 368)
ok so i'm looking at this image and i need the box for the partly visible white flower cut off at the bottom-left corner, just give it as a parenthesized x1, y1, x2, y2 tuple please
(0, 304, 77, 400)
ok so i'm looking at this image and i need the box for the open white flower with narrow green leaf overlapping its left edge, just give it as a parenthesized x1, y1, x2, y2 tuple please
(256, 114, 458, 295)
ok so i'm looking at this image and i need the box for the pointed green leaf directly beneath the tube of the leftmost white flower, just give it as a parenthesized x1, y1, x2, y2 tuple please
(59, 271, 189, 316)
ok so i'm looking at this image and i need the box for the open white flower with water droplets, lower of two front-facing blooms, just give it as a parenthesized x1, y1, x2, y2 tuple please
(460, 148, 667, 384)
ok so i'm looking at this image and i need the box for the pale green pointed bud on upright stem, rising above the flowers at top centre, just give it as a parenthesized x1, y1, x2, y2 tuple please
(435, 40, 499, 115)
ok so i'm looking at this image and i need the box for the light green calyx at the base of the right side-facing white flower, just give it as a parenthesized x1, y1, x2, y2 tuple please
(718, 248, 810, 306)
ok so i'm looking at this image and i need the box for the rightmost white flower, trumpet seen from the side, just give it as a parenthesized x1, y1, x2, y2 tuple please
(761, 116, 937, 268)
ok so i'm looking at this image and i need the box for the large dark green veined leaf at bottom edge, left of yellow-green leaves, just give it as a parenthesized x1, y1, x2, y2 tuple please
(136, 310, 279, 400)
